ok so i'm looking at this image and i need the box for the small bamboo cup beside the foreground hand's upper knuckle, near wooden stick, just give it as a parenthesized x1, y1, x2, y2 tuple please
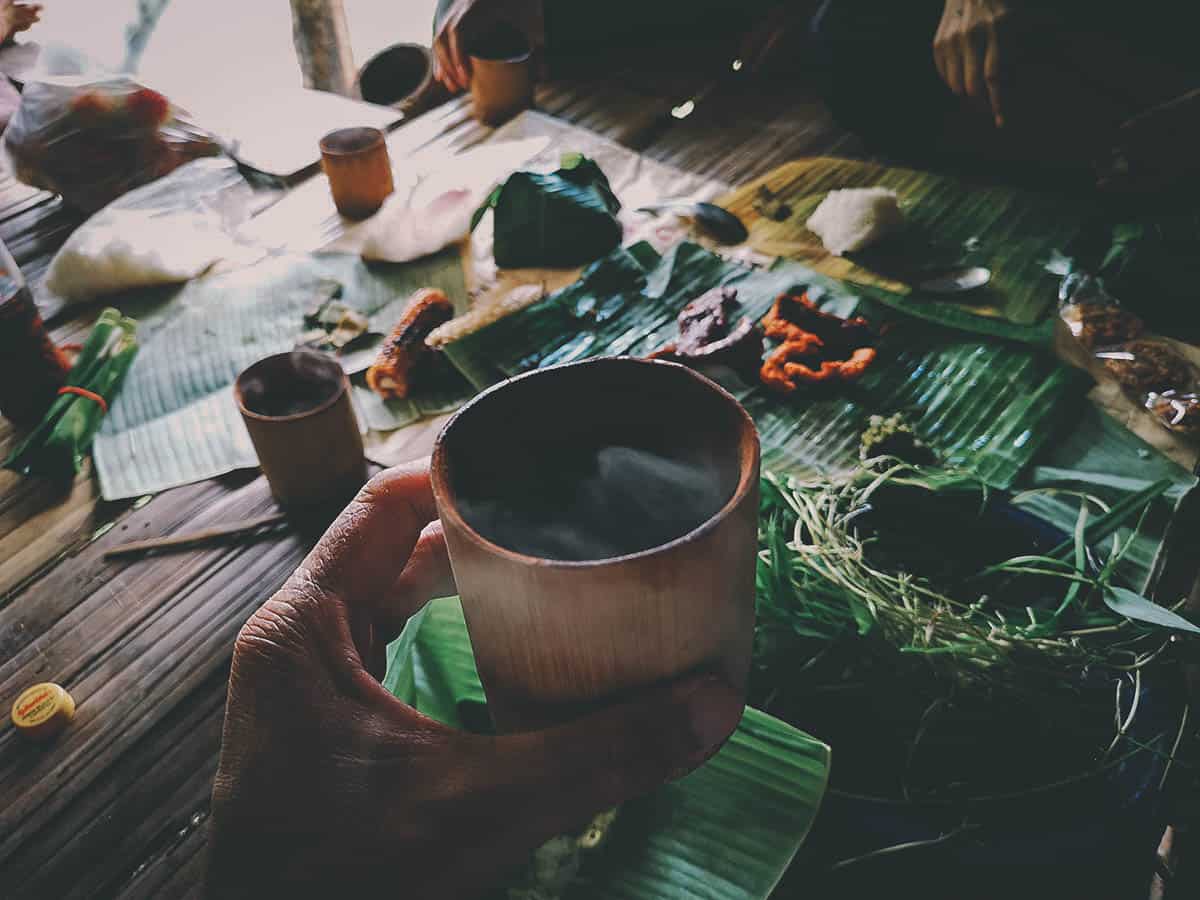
(234, 350, 367, 512)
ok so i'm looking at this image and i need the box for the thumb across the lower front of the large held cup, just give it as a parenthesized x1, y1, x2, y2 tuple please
(491, 676, 744, 842)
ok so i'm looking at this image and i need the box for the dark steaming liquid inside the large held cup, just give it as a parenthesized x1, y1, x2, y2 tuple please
(458, 444, 733, 560)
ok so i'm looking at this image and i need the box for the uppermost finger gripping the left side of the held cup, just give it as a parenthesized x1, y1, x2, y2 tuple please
(288, 460, 437, 608)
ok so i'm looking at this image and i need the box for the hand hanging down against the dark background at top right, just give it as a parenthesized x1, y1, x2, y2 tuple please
(934, 0, 1012, 128)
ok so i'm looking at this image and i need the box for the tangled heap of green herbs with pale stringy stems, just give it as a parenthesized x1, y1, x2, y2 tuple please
(758, 461, 1185, 688)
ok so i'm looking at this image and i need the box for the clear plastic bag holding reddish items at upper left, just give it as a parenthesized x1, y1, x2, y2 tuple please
(5, 76, 218, 212)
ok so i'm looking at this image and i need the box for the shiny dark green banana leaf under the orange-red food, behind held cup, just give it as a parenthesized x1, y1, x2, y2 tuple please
(445, 242, 1087, 487)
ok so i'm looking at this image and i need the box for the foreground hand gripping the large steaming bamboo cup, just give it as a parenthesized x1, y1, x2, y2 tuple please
(208, 466, 742, 900)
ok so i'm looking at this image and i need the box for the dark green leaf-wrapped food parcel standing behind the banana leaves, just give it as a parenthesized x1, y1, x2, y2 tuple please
(472, 154, 622, 269)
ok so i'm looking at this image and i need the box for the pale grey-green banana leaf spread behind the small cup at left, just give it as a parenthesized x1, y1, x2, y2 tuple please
(94, 251, 469, 499)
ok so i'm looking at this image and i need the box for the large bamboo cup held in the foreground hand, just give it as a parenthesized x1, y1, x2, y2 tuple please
(432, 358, 758, 732)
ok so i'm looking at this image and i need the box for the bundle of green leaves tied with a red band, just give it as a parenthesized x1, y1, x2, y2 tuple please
(4, 310, 138, 480)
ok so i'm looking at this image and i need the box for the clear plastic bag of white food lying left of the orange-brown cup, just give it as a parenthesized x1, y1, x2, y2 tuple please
(46, 158, 266, 302)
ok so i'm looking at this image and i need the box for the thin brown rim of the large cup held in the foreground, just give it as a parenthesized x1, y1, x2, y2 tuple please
(430, 356, 762, 570)
